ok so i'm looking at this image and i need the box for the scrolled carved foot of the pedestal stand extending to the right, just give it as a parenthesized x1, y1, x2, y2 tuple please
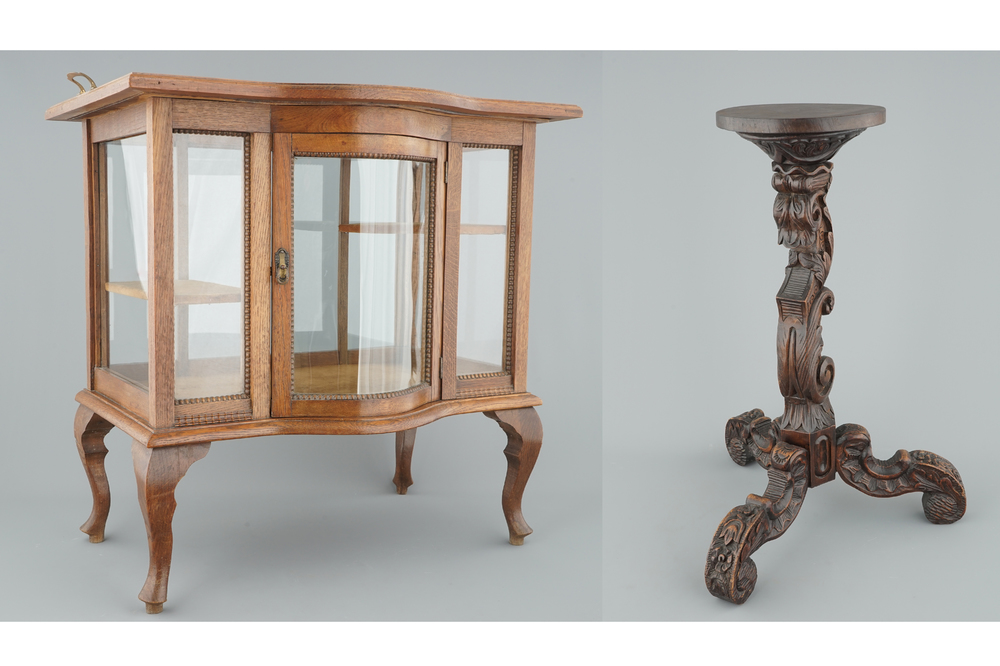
(837, 423, 966, 525)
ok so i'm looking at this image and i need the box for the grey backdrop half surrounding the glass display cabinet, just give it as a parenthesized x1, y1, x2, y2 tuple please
(0, 52, 601, 621)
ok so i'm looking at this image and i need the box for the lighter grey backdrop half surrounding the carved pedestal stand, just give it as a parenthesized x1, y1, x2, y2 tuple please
(603, 53, 1000, 621)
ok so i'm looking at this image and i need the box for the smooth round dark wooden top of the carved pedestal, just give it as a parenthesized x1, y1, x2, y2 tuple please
(715, 104, 885, 134)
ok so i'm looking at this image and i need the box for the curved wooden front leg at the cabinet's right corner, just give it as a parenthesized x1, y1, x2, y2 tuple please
(484, 407, 542, 546)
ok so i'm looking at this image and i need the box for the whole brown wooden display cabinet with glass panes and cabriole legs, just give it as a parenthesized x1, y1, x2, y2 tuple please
(46, 74, 582, 613)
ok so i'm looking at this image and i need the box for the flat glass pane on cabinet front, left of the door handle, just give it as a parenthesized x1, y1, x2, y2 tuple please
(173, 132, 249, 400)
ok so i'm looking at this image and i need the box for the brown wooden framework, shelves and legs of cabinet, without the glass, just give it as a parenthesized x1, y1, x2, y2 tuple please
(46, 74, 582, 613)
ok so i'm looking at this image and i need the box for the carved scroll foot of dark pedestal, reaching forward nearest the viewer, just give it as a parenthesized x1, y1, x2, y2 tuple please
(705, 420, 809, 604)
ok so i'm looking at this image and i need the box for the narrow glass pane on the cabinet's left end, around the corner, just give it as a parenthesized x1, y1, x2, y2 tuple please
(99, 135, 149, 390)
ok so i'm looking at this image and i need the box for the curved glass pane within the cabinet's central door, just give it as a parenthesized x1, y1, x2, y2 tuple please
(292, 157, 431, 396)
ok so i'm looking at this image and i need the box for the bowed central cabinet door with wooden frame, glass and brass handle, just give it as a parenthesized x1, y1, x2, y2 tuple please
(272, 135, 443, 416)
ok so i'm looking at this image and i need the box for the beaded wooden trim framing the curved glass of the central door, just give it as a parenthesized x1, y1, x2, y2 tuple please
(289, 151, 437, 400)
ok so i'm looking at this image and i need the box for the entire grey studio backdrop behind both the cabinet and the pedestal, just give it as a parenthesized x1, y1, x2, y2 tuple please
(0, 52, 1000, 622)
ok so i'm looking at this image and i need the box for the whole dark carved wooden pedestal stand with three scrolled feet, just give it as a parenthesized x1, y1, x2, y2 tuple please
(705, 104, 965, 604)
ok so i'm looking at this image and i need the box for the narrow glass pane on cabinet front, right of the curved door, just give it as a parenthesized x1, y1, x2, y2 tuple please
(456, 146, 512, 377)
